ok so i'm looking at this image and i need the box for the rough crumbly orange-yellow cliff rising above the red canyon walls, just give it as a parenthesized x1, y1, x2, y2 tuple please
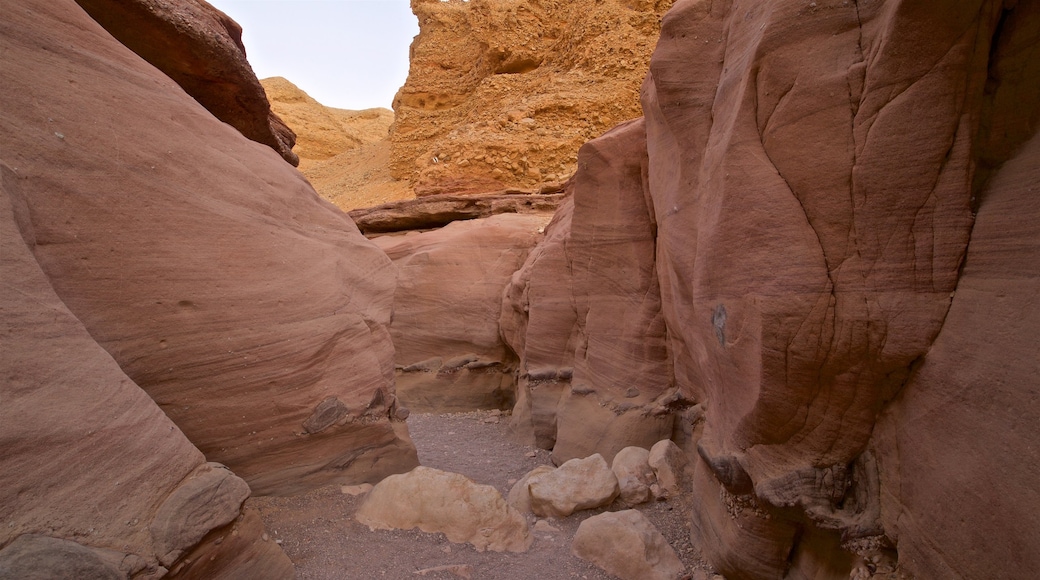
(391, 0, 672, 195)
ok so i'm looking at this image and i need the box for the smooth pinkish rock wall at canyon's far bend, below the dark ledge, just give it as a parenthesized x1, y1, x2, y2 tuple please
(373, 214, 549, 413)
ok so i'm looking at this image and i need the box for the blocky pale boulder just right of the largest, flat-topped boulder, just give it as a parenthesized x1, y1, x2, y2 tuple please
(527, 453, 619, 518)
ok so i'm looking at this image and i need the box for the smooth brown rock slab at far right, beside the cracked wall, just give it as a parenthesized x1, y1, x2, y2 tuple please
(877, 129, 1040, 578)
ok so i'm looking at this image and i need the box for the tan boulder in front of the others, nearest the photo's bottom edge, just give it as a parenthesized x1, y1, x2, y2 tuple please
(571, 509, 685, 580)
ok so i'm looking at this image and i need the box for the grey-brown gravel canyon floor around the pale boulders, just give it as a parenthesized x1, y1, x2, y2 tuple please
(250, 412, 710, 580)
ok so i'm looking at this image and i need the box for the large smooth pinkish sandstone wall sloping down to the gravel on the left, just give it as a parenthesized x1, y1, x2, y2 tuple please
(0, 0, 417, 494)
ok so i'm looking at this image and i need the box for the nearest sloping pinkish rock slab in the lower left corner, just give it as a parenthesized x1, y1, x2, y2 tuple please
(0, 168, 293, 579)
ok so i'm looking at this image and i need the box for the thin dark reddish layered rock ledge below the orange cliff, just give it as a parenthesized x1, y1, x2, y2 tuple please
(350, 190, 565, 235)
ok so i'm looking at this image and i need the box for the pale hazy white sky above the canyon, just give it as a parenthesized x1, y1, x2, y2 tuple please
(207, 0, 419, 109)
